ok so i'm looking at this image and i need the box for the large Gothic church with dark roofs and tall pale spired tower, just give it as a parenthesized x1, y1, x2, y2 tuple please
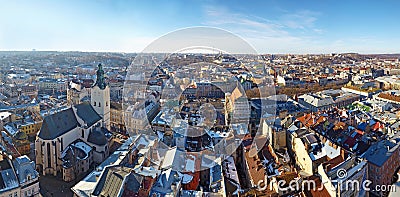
(35, 64, 111, 181)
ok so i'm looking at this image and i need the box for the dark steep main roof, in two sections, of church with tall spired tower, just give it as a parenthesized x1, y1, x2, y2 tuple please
(38, 103, 101, 140)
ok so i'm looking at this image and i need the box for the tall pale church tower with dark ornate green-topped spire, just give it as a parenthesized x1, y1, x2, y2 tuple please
(91, 64, 110, 130)
